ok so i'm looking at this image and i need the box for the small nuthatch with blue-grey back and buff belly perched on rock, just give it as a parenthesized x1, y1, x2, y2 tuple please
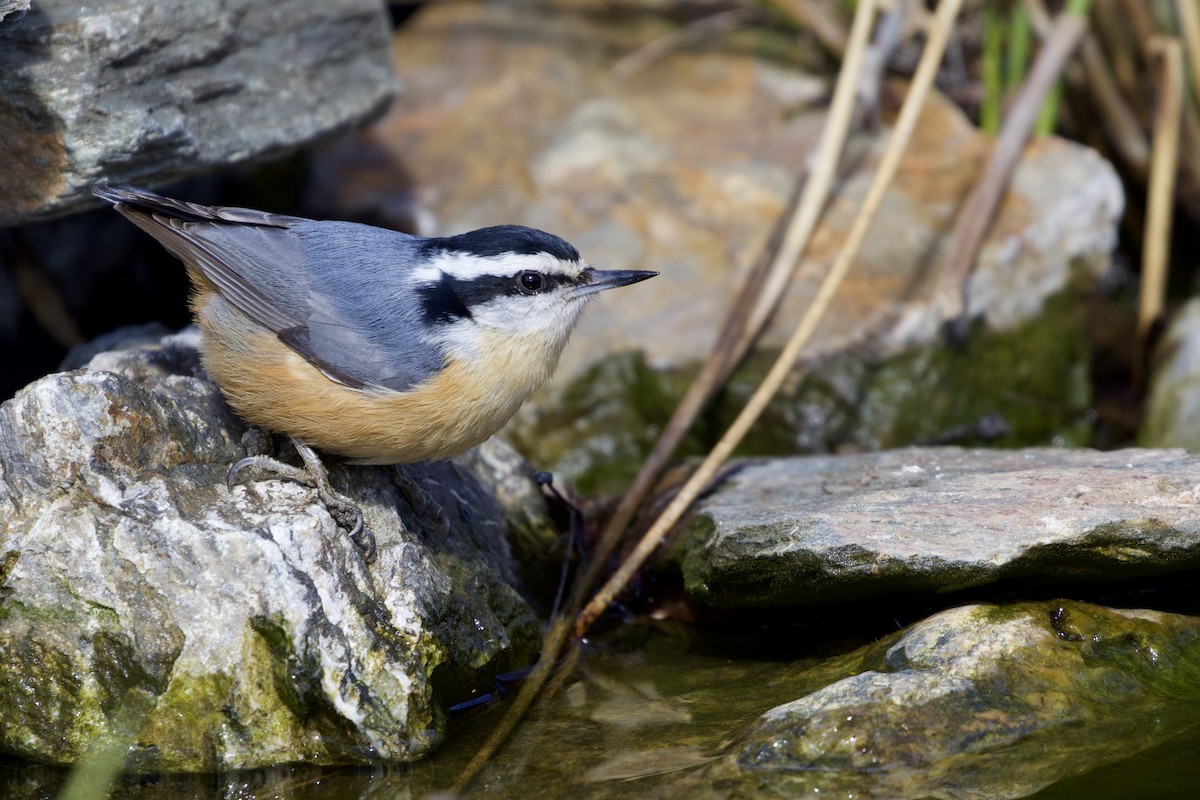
(92, 185, 658, 561)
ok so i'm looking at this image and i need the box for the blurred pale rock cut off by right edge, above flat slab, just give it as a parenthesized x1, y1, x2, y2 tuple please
(1139, 300, 1200, 450)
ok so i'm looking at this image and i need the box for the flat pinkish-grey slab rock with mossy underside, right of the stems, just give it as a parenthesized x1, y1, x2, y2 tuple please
(683, 447, 1200, 608)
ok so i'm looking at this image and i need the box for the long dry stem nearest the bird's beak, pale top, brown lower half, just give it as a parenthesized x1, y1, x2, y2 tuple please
(572, 0, 875, 608)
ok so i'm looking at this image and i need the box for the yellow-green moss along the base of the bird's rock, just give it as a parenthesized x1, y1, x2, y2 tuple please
(0, 615, 420, 772)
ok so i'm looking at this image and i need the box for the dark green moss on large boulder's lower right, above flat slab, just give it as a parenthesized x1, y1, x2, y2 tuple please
(796, 290, 1091, 450)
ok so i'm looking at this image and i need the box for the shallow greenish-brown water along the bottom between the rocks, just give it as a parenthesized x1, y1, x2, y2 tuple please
(0, 606, 1200, 800)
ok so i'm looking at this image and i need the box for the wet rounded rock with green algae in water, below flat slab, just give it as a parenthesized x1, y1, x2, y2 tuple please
(700, 601, 1200, 800)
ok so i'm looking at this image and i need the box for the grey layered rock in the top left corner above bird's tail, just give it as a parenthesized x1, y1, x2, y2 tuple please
(0, 0, 395, 224)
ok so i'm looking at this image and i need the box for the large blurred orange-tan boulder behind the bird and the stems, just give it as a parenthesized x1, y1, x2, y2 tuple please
(323, 4, 1123, 489)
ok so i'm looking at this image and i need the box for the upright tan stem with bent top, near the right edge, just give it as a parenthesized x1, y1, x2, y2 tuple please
(1134, 37, 1183, 347)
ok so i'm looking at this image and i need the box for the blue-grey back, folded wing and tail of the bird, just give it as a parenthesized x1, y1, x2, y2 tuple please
(96, 187, 444, 391)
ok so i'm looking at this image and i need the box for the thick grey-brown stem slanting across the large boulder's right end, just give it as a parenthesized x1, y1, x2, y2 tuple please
(942, 12, 1087, 319)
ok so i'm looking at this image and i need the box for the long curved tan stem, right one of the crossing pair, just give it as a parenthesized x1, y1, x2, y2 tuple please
(575, 0, 962, 637)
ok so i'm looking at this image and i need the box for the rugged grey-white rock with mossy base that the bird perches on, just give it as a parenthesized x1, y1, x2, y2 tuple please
(0, 331, 538, 771)
